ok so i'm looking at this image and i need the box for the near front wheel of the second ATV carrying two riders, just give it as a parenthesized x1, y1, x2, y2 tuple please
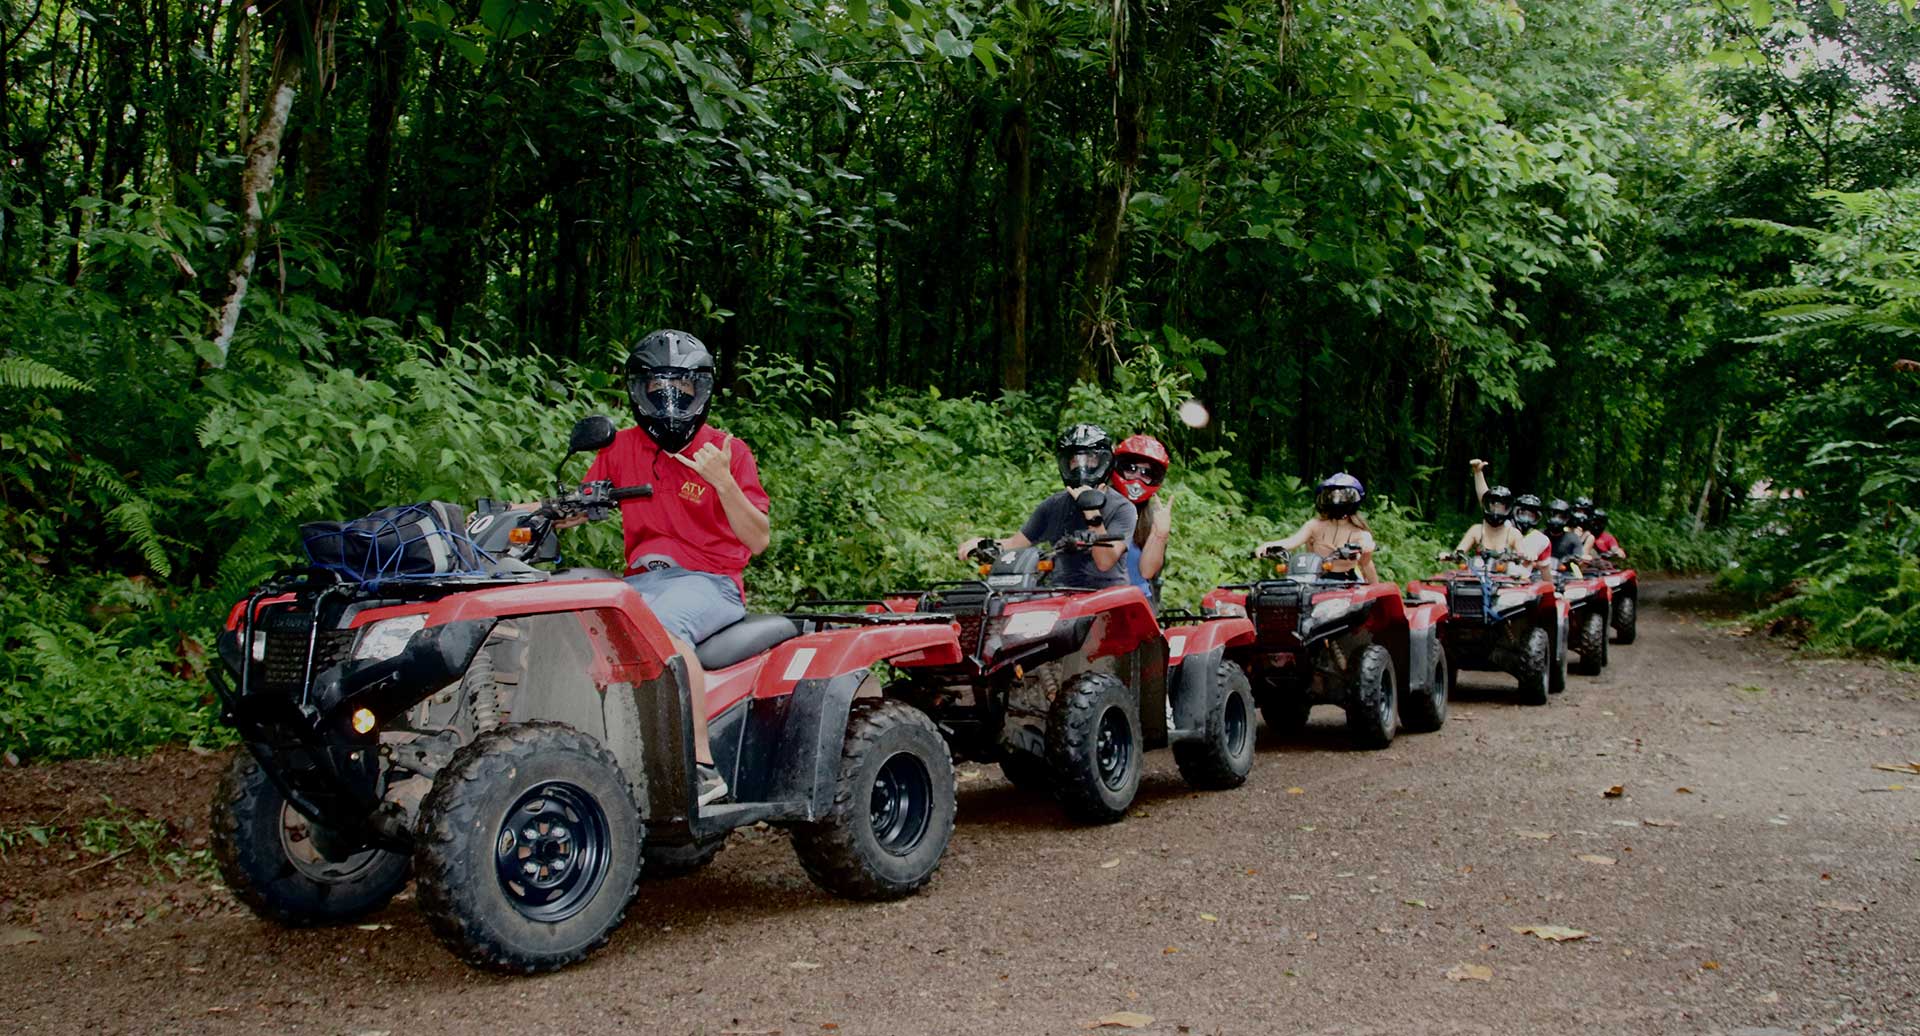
(1046, 673, 1144, 823)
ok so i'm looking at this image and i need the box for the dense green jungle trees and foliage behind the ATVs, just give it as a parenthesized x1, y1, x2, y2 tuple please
(0, 0, 1920, 758)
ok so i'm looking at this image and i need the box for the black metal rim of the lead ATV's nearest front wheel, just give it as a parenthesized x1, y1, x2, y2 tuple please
(493, 781, 612, 923)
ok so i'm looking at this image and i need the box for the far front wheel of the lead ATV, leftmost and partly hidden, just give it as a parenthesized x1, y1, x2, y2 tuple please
(211, 748, 407, 929)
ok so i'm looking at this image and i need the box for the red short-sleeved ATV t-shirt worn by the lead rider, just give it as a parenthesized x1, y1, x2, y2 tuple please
(588, 426, 770, 597)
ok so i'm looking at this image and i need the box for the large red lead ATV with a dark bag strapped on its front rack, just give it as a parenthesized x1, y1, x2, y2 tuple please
(213, 418, 975, 973)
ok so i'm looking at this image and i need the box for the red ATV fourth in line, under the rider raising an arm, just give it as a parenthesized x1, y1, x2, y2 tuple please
(1407, 551, 1567, 706)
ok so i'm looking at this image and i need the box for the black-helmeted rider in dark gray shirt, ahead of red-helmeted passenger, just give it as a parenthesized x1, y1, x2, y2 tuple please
(958, 424, 1137, 589)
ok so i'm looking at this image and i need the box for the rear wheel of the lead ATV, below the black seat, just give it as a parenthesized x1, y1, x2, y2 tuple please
(793, 700, 956, 900)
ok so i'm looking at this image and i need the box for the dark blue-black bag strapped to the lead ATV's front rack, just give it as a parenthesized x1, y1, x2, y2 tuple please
(300, 501, 486, 583)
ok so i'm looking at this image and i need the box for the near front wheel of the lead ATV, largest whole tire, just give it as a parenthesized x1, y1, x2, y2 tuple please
(415, 721, 645, 975)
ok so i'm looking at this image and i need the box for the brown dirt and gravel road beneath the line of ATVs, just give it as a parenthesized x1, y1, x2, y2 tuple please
(0, 583, 1920, 1036)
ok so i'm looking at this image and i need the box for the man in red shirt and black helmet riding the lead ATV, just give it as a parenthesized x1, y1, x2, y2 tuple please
(588, 330, 772, 806)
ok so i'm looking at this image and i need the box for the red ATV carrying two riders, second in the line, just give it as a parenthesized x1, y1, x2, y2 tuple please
(885, 518, 1254, 823)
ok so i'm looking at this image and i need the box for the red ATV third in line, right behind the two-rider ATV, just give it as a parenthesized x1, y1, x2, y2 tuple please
(1202, 547, 1452, 748)
